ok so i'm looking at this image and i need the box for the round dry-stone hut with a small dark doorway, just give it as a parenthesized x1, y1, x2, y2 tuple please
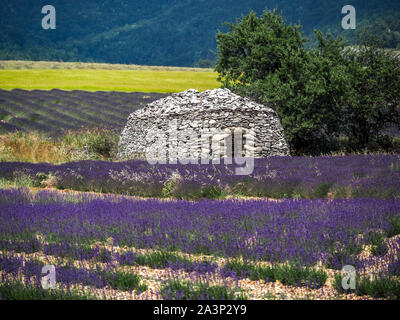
(118, 89, 289, 160)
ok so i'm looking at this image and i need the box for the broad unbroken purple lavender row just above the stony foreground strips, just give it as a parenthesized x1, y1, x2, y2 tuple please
(0, 190, 400, 265)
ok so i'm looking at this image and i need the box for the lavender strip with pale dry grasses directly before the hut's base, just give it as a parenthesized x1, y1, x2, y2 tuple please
(0, 155, 400, 200)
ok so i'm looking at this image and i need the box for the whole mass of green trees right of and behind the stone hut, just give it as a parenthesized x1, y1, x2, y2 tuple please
(215, 10, 400, 154)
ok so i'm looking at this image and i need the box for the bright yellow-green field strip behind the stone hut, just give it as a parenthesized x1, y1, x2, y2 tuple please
(0, 69, 220, 93)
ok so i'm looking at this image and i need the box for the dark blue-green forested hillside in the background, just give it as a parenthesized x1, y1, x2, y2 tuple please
(0, 0, 400, 67)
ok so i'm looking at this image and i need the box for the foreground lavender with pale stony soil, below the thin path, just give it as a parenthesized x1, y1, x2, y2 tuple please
(0, 188, 400, 299)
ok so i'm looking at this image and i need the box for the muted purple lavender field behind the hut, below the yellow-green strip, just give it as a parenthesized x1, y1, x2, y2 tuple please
(0, 89, 165, 135)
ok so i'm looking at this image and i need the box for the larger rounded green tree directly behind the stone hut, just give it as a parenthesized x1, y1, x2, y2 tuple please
(215, 10, 350, 154)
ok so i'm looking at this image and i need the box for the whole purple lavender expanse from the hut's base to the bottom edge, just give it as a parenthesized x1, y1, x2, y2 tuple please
(0, 155, 400, 299)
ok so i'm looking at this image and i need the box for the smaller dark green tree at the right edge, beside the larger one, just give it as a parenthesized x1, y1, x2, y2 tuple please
(343, 38, 400, 150)
